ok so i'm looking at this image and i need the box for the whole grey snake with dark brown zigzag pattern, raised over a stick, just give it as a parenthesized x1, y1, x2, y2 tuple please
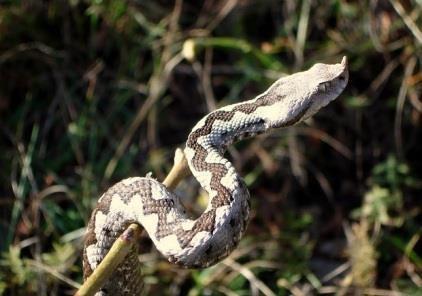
(83, 57, 349, 296)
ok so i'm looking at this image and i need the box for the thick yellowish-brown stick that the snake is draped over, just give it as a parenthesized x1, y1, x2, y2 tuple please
(75, 148, 190, 296)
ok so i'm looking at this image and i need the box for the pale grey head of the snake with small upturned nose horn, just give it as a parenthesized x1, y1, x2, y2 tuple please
(256, 57, 349, 128)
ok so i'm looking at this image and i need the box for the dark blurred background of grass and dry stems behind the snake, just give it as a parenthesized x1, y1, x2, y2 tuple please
(0, 0, 422, 296)
